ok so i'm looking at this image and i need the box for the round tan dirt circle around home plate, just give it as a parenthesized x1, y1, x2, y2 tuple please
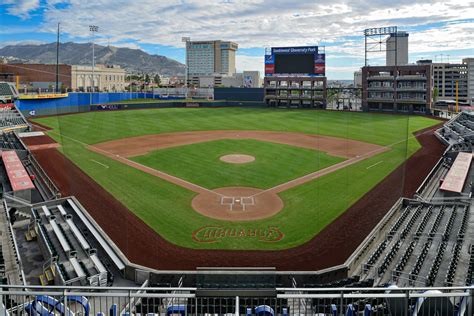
(192, 187, 284, 221)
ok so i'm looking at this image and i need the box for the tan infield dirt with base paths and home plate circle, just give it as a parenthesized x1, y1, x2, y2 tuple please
(88, 131, 389, 221)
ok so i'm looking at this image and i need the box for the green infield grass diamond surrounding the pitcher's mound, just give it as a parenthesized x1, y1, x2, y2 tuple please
(131, 139, 344, 189)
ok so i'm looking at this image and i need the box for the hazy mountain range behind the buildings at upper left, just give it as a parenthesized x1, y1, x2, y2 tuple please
(0, 42, 185, 76)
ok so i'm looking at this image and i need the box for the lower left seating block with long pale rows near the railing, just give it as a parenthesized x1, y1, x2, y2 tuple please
(26, 199, 122, 286)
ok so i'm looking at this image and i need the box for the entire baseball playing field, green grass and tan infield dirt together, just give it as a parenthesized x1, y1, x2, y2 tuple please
(34, 108, 439, 250)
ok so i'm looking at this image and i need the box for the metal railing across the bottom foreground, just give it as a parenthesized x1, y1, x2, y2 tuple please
(0, 285, 474, 316)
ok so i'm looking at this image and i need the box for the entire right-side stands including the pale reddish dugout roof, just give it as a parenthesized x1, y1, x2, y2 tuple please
(352, 112, 474, 287)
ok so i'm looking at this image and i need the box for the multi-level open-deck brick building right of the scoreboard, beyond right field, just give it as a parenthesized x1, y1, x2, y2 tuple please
(362, 64, 433, 113)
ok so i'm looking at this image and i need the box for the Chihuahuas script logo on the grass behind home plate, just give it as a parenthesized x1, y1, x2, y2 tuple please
(193, 225, 285, 243)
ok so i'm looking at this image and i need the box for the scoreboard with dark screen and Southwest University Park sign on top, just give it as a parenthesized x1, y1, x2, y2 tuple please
(265, 46, 326, 77)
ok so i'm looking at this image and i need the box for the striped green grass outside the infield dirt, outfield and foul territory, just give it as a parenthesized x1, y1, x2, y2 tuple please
(36, 108, 437, 249)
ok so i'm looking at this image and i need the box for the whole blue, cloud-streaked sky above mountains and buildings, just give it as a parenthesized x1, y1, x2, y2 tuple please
(0, 0, 474, 80)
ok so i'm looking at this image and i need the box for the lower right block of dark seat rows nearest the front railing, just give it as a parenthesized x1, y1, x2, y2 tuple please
(355, 201, 474, 286)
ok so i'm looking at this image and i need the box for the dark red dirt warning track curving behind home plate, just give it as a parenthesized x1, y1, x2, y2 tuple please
(29, 124, 444, 271)
